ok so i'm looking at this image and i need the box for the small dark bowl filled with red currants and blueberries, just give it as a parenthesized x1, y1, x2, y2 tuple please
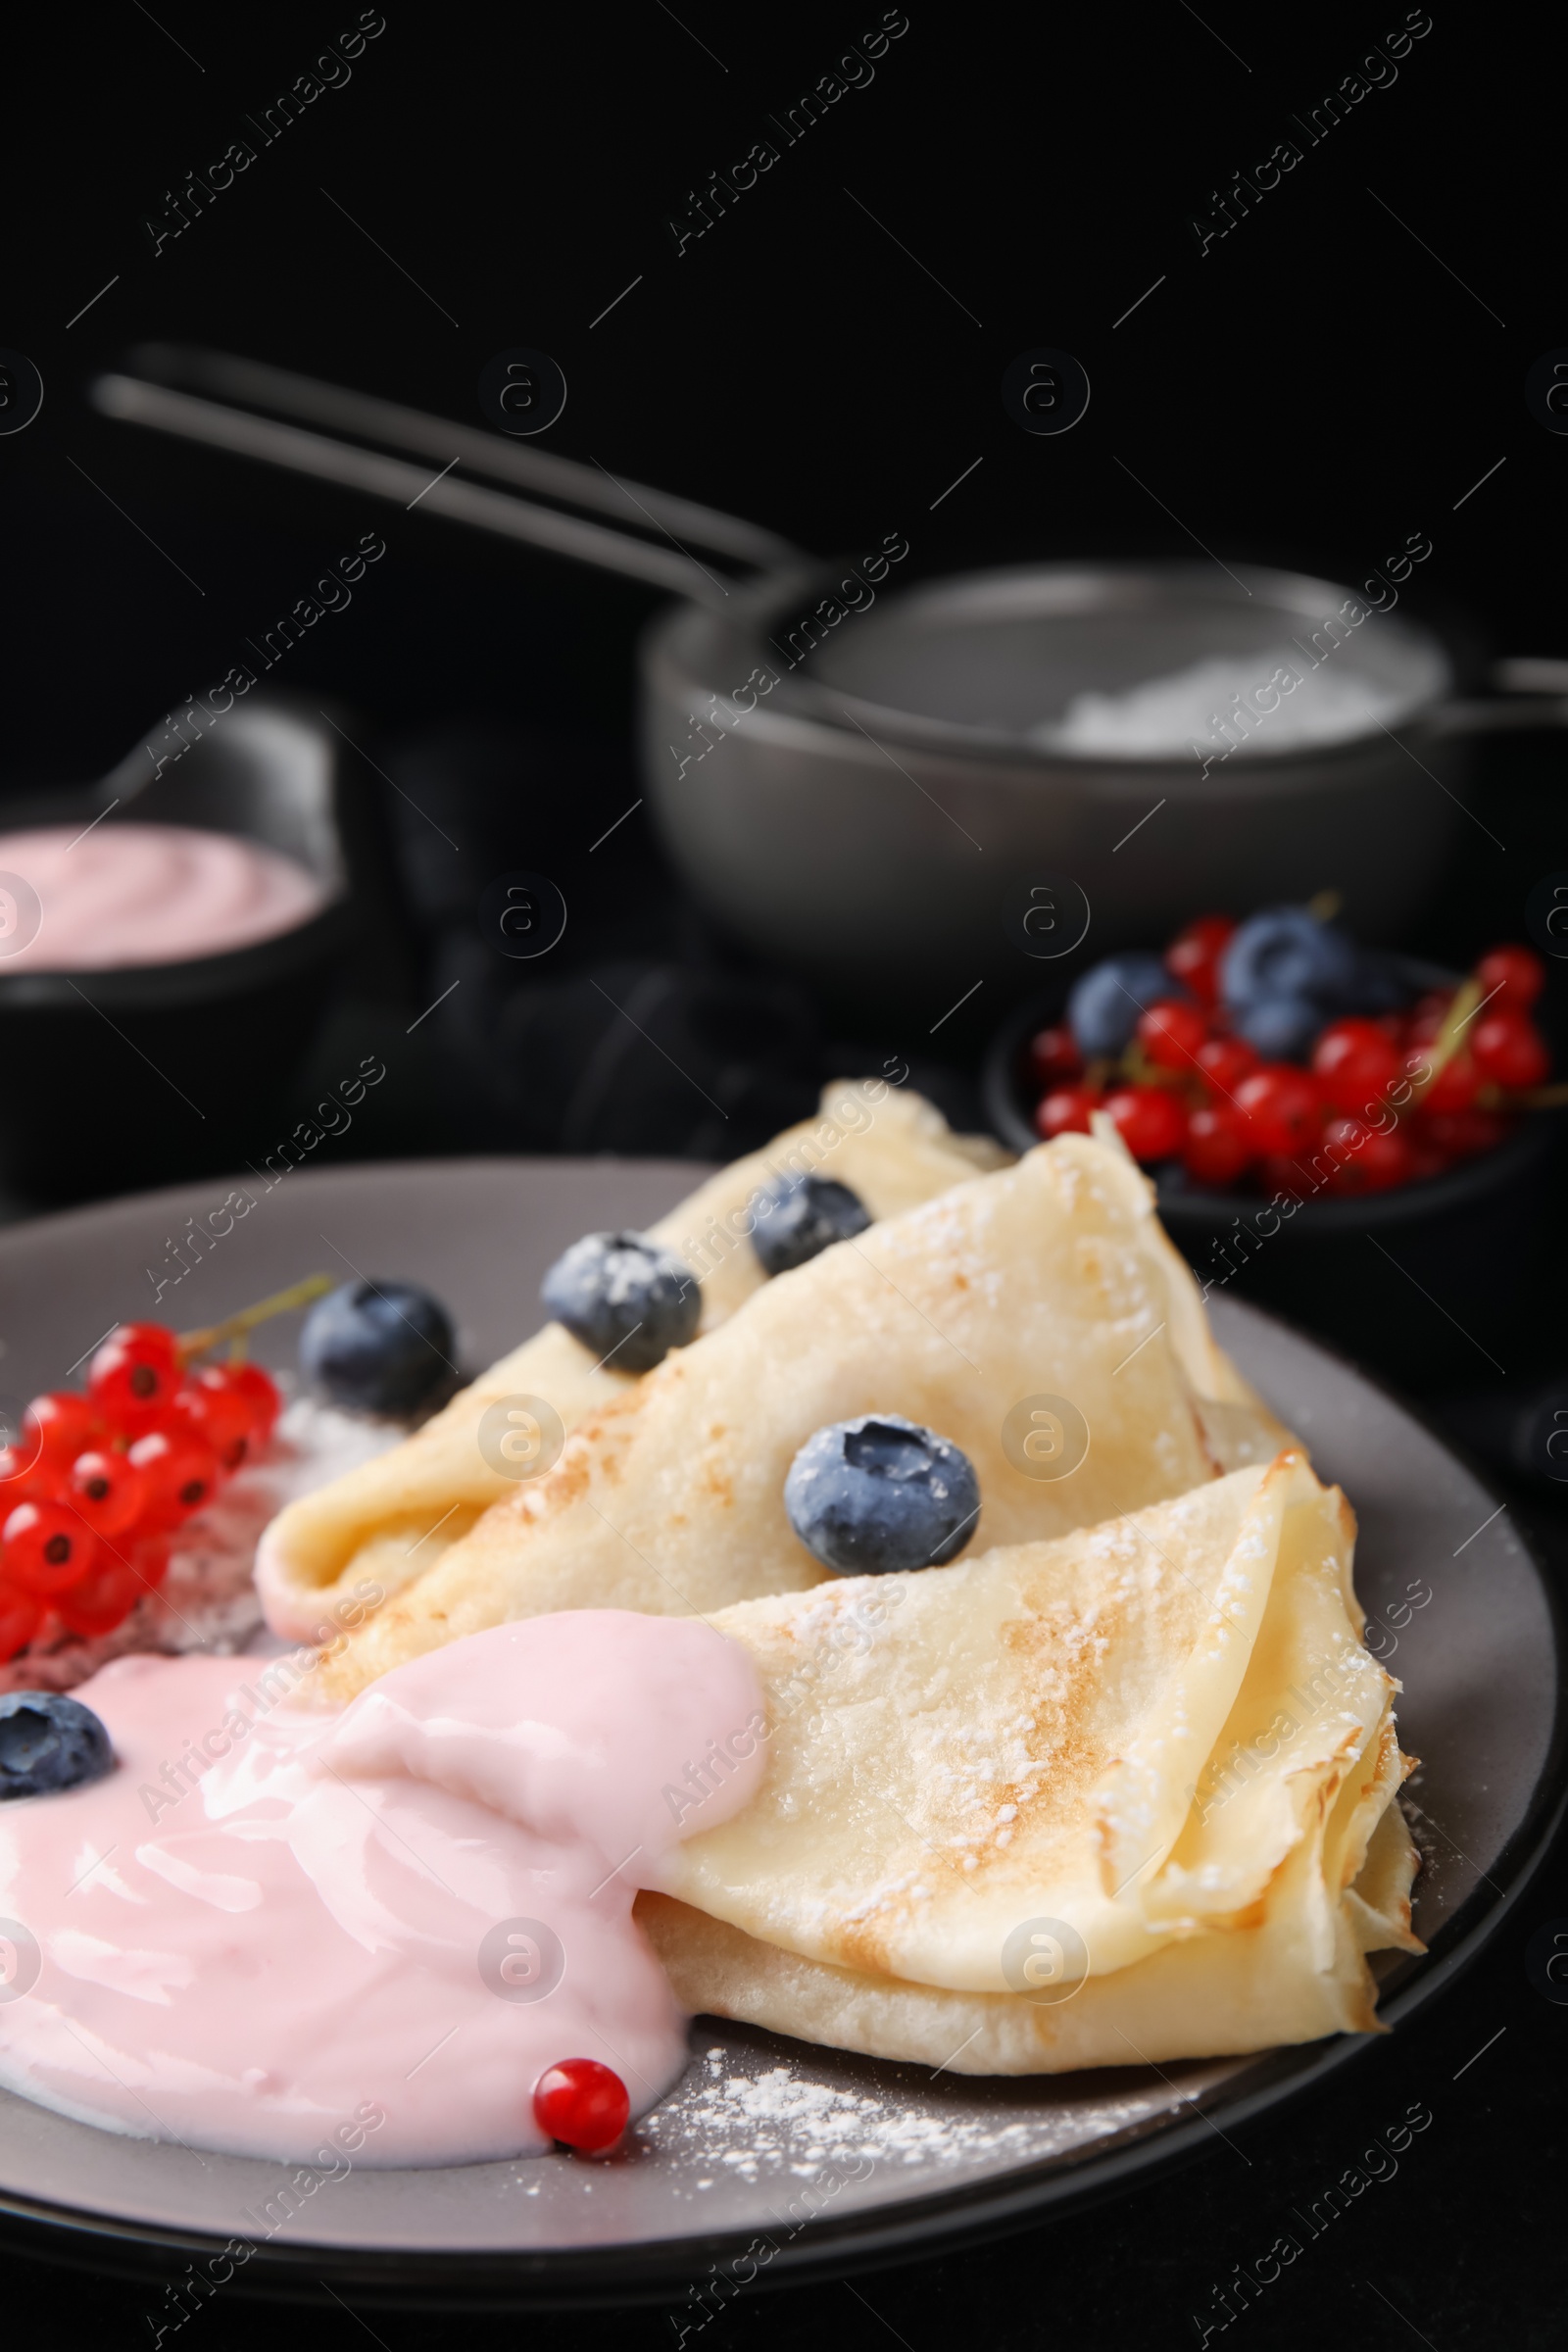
(983, 899, 1568, 1386)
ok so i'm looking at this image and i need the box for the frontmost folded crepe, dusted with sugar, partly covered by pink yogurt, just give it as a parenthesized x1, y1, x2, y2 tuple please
(637, 1451, 1422, 2075)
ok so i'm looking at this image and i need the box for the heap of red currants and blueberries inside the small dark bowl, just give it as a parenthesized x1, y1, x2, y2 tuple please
(1022, 906, 1563, 1198)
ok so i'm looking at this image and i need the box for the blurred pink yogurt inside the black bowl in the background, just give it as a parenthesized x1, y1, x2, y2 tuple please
(0, 818, 324, 976)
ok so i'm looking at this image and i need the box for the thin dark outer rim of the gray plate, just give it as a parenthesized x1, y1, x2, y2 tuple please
(0, 1152, 1568, 2317)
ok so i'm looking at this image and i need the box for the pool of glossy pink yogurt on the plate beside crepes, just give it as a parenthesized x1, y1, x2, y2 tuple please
(0, 1609, 766, 2166)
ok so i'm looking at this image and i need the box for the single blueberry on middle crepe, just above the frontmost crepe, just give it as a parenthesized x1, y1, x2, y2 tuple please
(785, 1413, 980, 1576)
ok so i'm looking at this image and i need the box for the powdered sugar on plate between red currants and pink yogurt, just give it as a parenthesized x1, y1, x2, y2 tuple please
(0, 1376, 407, 1691)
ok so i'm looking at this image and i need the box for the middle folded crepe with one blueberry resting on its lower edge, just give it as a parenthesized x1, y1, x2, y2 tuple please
(313, 1136, 1286, 1703)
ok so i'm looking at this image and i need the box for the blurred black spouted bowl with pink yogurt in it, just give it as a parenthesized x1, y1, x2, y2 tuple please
(0, 701, 362, 1204)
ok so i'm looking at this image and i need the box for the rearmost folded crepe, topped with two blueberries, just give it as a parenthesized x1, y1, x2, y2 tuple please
(256, 1080, 1008, 1642)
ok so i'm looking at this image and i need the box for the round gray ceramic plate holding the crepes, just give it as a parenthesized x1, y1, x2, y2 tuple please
(0, 1146, 1561, 2322)
